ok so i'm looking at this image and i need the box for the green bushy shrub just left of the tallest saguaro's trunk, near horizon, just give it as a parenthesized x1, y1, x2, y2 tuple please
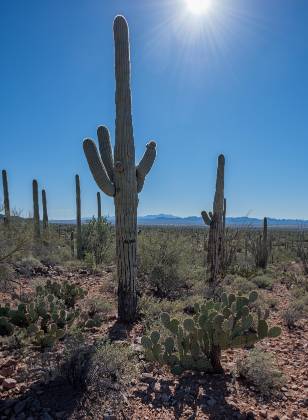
(82, 217, 114, 265)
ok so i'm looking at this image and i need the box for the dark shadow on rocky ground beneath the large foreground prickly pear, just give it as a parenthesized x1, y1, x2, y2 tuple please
(134, 374, 246, 420)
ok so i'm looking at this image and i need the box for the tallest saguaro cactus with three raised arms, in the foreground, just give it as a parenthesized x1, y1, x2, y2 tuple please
(84, 16, 156, 322)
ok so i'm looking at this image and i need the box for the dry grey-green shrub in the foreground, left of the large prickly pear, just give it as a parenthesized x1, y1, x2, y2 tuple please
(58, 338, 138, 412)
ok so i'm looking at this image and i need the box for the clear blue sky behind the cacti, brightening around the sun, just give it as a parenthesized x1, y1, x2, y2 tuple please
(0, 0, 308, 219)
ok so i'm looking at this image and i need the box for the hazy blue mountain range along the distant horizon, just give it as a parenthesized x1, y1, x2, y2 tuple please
(50, 214, 308, 228)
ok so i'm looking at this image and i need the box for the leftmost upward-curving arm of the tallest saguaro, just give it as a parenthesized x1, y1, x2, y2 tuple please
(83, 139, 115, 197)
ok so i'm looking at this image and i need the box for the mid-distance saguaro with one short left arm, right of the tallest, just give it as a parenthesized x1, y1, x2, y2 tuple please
(201, 155, 226, 286)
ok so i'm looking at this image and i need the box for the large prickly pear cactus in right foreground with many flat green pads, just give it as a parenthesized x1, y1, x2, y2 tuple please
(141, 291, 281, 374)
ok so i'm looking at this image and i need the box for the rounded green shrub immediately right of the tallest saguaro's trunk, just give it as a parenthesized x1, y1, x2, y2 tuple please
(138, 235, 187, 298)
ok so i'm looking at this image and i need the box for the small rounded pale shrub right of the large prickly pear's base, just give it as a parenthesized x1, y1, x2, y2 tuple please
(237, 349, 285, 396)
